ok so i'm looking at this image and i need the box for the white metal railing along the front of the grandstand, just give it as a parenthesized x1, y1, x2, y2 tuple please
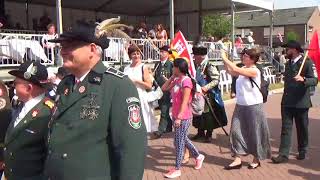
(0, 31, 255, 67)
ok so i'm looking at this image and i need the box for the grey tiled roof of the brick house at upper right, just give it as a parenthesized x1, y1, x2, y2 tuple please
(235, 7, 316, 28)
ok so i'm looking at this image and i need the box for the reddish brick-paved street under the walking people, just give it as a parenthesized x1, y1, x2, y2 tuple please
(143, 91, 320, 180)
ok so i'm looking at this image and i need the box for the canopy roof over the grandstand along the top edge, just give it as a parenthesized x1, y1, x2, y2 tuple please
(10, 0, 273, 16)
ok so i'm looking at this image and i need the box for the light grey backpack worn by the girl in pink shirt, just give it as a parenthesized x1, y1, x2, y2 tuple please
(180, 77, 205, 116)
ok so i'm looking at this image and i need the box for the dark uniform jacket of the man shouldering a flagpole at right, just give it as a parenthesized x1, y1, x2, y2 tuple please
(281, 57, 318, 108)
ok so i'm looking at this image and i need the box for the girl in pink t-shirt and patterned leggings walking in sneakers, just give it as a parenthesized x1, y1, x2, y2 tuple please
(162, 58, 205, 178)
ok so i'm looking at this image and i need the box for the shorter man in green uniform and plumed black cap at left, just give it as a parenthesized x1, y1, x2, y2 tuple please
(4, 61, 54, 180)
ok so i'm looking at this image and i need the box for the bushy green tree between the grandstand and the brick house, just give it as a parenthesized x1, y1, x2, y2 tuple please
(202, 14, 232, 37)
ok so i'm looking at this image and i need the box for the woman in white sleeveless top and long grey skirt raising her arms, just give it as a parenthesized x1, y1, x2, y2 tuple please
(221, 49, 271, 170)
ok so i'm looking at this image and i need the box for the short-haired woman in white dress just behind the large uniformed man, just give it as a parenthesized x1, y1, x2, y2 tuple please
(124, 46, 158, 132)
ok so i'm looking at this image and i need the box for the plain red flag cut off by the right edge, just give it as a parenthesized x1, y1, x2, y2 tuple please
(309, 31, 320, 80)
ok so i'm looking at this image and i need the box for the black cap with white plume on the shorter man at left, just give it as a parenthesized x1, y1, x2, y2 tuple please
(9, 61, 48, 88)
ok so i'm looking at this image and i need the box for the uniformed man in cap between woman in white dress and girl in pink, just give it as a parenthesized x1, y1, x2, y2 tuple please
(154, 46, 173, 138)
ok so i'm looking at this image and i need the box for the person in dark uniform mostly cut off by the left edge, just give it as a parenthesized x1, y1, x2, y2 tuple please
(0, 80, 11, 174)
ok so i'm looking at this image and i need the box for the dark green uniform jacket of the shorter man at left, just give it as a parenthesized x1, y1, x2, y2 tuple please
(4, 98, 53, 180)
